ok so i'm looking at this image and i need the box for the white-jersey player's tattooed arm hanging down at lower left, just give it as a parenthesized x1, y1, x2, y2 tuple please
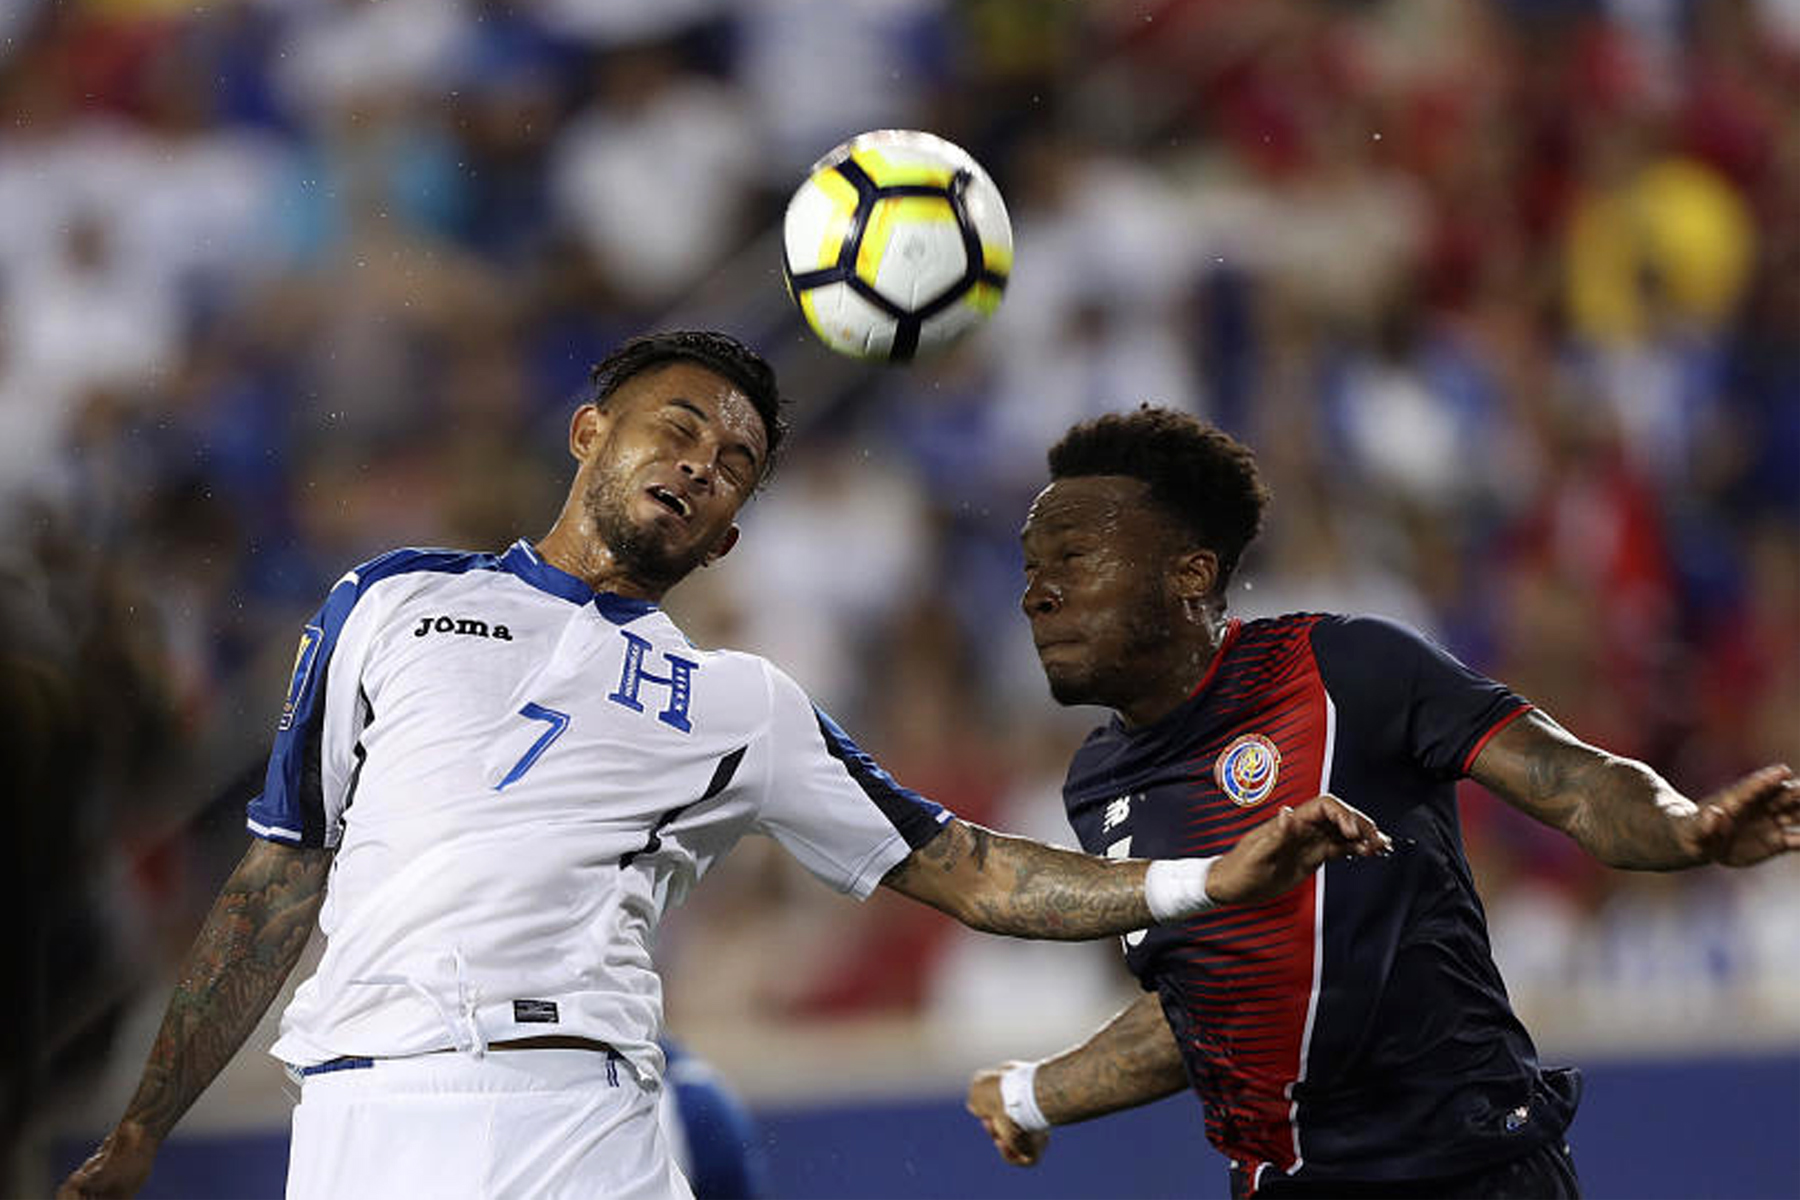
(56, 838, 331, 1196)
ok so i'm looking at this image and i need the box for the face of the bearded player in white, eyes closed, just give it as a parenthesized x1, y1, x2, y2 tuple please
(572, 362, 769, 588)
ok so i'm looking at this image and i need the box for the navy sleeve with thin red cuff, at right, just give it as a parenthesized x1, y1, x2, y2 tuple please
(1312, 617, 1532, 779)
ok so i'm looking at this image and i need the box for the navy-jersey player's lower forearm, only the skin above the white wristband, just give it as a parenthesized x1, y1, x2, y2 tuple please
(1037, 995, 1188, 1124)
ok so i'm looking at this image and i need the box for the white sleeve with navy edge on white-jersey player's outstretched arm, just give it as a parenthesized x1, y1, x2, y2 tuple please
(756, 667, 950, 898)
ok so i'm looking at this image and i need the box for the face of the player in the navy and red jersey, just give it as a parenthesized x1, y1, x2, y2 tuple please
(1021, 475, 1181, 711)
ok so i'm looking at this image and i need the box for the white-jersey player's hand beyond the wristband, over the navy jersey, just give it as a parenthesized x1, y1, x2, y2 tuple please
(1206, 795, 1393, 905)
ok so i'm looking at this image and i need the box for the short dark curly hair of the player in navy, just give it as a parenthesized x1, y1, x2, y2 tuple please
(1049, 405, 1269, 596)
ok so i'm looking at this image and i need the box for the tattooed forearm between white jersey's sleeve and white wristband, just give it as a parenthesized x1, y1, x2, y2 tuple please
(886, 820, 1152, 941)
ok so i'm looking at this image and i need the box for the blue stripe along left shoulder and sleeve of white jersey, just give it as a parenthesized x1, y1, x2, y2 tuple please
(247, 549, 499, 846)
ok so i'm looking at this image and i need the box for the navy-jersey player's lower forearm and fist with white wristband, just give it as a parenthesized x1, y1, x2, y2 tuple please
(967, 993, 1188, 1166)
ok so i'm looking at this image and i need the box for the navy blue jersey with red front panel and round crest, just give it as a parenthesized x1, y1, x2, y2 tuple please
(1064, 615, 1570, 1195)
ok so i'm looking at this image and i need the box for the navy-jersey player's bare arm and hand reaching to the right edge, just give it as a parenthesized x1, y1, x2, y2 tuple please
(1469, 711, 1800, 871)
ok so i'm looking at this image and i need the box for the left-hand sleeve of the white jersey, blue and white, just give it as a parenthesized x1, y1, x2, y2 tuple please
(245, 569, 379, 847)
